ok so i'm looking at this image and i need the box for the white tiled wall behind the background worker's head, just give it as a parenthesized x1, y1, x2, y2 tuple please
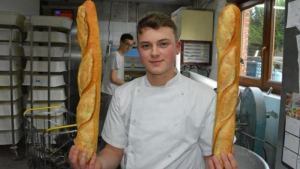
(99, 21, 136, 54)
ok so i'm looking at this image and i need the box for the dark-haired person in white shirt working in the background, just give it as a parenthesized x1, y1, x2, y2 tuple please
(99, 33, 134, 150)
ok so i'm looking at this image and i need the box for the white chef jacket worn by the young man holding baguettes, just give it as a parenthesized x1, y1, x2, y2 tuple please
(102, 73, 216, 169)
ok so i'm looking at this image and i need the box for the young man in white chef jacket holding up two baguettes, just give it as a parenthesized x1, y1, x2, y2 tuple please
(69, 13, 237, 169)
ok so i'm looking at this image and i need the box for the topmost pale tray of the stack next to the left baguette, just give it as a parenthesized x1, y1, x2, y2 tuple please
(30, 16, 73, 30)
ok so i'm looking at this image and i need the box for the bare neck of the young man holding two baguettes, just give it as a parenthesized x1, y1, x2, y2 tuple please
(147, 70, 176, 86)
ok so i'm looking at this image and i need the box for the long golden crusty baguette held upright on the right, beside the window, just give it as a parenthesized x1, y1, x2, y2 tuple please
(213, 5, 241, 166)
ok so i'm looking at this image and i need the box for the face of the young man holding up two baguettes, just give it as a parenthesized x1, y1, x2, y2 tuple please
(138, 27, 181, 75)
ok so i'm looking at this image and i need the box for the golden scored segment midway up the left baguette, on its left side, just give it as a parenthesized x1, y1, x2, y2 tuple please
(77, 49, 94, 96)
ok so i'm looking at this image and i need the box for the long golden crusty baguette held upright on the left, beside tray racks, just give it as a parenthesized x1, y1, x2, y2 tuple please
(75, 0, 102, 162)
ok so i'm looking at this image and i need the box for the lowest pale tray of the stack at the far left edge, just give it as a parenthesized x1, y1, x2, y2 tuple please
(0, 125, 23, 145)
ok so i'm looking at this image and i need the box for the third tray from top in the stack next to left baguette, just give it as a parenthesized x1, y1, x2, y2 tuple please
(23, 46, 65, 57)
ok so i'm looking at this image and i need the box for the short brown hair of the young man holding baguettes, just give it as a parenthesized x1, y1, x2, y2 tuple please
(136, 12, 177, 41)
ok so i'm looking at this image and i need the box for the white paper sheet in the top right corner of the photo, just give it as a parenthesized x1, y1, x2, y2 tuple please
(286, 0, 300, 29)
